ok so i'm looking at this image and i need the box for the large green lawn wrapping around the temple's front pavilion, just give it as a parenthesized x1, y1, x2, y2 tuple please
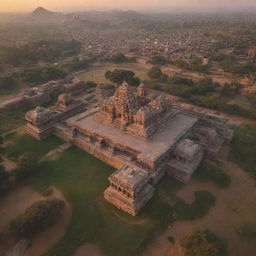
(23, 142, 216, 256)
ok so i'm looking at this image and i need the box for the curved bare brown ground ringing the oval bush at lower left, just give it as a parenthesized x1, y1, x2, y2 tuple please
(0, 186, 72, 256)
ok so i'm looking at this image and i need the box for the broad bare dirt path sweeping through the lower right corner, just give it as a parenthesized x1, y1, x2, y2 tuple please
(143, 146, 256, 256)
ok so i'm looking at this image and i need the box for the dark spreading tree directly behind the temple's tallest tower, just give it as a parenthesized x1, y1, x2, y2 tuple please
(105, 69, 141, 86)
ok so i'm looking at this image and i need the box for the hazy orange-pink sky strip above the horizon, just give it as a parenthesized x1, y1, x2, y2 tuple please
(0, 0, 256, 12)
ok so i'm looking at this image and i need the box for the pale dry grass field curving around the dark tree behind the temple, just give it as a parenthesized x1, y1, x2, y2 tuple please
(78, 63, 148, 83)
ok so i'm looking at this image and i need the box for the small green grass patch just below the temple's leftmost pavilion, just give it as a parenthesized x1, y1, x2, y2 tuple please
(7, 134, 63, 160)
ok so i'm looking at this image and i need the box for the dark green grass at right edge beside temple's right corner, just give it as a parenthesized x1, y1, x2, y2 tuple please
(229, 126, 256, 179)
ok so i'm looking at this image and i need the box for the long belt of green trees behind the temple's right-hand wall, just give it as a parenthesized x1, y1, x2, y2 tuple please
(146, 67, 256, 119)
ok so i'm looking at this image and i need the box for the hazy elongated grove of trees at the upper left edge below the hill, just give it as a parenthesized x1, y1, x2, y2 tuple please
(0, 40, 82, 65)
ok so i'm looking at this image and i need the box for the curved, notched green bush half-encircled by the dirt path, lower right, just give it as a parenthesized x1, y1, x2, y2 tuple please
(174, 191, 215, 220)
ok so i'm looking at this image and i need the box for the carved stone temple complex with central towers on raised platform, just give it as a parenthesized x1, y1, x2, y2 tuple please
(25, 82, 232, 216)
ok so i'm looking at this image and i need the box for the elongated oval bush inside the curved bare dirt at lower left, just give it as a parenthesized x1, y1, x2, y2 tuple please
(9, 199, 65, 237)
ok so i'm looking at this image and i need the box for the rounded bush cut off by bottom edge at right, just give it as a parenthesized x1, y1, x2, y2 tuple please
(181, 230, 227, 256)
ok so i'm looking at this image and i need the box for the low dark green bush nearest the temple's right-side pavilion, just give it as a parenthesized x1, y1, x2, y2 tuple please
(194, 162, 231, 188)
